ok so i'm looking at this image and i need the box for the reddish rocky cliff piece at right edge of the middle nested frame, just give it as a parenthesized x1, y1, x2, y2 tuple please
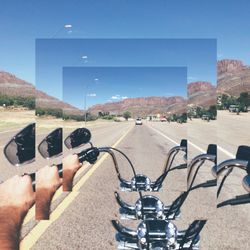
(188, 82, 216, 108)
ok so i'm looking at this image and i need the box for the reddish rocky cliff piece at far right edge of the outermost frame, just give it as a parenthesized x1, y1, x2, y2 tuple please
(217, 59, 250, 96)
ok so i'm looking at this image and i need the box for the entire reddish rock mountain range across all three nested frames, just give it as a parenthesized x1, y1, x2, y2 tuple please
(0, 59, 250, 116)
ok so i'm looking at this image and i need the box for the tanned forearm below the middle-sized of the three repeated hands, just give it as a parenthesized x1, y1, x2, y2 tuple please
(36, 188, 54, 220)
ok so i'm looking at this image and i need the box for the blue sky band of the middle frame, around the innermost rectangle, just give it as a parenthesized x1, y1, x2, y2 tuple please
(36, 39, 216, 99)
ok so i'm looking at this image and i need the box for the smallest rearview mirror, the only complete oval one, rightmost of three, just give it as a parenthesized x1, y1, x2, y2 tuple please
(64, 128, 91, 149)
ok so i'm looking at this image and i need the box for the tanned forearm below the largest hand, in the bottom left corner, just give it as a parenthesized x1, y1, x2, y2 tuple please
(0, 206, 23, 250)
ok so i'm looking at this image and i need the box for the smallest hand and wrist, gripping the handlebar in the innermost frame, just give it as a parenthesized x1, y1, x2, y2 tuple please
(63, 154, 82, 191)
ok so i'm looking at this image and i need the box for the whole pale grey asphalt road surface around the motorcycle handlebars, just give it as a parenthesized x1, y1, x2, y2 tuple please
(0, 117, 250, 250)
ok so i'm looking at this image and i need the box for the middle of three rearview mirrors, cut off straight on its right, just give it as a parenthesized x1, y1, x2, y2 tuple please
(38, 128, 62, 159)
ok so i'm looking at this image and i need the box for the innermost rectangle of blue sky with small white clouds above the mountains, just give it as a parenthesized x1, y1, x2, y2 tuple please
(63, 67, 187, 109)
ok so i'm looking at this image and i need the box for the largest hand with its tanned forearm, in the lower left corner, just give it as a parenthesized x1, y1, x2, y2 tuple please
(0, 175, 35, 249)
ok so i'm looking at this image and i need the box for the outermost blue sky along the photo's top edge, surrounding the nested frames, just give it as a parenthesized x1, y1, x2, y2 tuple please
(0, 0, 250, 83)
